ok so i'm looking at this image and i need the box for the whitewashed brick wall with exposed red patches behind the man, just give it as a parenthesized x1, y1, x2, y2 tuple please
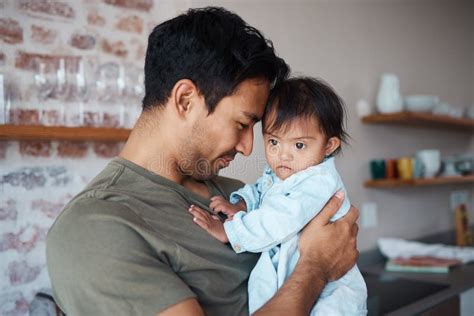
(0, 0, 181, 315)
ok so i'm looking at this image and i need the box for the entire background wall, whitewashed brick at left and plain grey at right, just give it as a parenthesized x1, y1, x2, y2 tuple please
(0, 0, 474, 315)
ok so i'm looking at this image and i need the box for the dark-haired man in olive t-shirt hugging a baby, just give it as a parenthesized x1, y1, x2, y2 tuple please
(47, 8, 358, 316)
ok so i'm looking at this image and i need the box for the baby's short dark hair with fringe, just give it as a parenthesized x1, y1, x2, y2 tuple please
(262, 77, 349, 155)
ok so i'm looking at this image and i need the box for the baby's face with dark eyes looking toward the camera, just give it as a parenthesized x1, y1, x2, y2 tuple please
(263, 118, 330, 180)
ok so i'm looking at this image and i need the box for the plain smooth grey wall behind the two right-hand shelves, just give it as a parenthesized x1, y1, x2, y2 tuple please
(214, 0, 474, 250)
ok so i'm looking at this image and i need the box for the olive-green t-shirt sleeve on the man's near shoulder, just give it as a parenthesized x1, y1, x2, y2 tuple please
(47, 200, 196, 315)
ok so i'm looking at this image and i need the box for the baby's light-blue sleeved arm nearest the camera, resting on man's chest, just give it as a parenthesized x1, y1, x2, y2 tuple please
(224, 172, 349, 252)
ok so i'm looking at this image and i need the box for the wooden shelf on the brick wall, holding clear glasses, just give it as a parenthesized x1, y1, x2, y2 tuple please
(0, 125, 130, 142)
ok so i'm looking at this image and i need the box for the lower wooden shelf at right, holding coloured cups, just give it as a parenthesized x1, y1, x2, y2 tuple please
(364, 175, 474, 188)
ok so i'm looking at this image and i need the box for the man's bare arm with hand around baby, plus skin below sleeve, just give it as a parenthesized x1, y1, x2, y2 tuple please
(158, 193, 359, 316)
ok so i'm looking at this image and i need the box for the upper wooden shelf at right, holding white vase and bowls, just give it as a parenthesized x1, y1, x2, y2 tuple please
(362, 112, 474, 132)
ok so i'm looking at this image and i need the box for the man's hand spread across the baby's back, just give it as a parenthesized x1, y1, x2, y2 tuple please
(299, 192, 359, 282)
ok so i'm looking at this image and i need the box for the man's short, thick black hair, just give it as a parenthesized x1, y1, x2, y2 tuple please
(143, 7, 289, 113)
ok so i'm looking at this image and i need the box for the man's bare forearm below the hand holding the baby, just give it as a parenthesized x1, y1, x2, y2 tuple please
(254, 260, 326, 316)
